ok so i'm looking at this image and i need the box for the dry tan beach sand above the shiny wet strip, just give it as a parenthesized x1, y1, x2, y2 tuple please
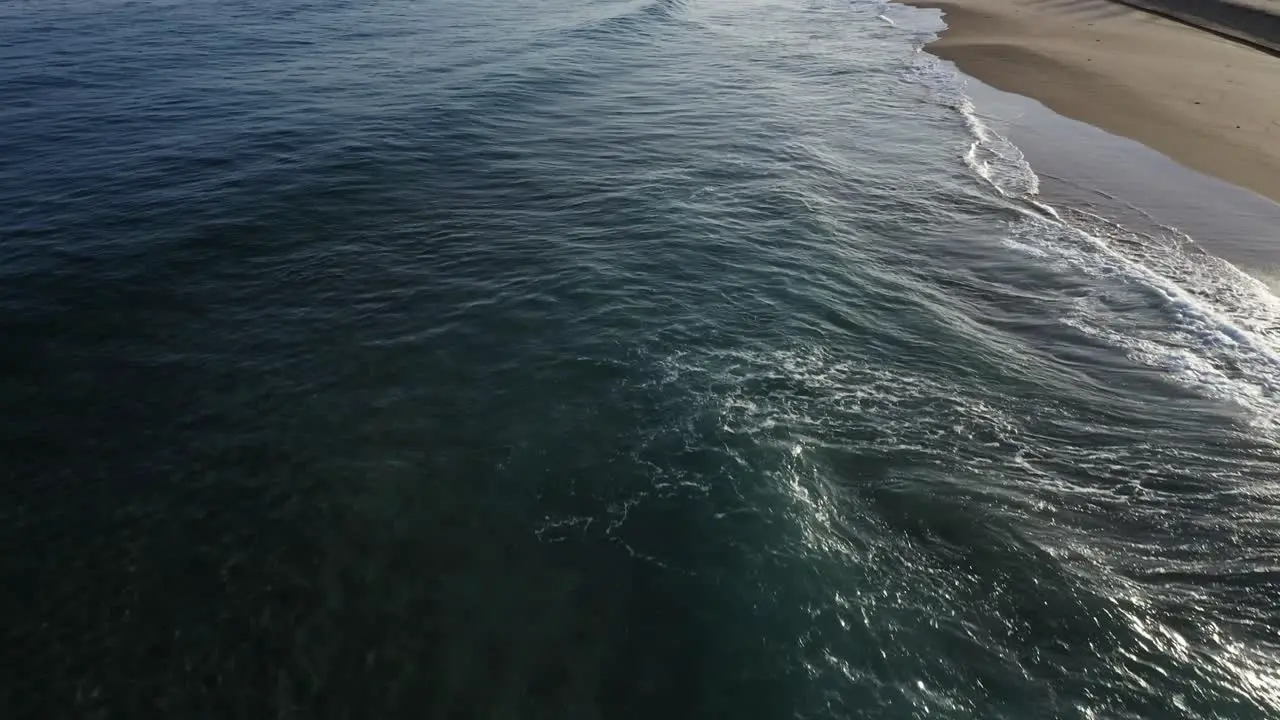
(910, 0, 1280, 202)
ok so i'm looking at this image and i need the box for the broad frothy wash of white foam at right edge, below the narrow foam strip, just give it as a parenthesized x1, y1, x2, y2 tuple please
(1006, 213, 1280, 430)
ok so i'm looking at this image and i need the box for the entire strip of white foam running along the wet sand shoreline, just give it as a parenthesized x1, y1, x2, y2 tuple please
(909, 11, 1280, 430)
